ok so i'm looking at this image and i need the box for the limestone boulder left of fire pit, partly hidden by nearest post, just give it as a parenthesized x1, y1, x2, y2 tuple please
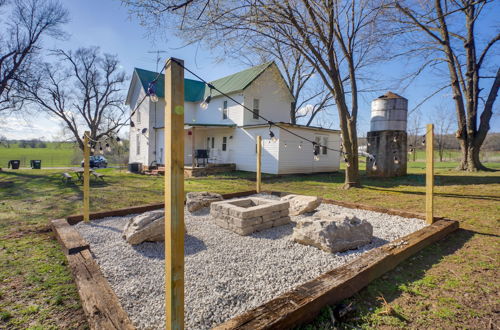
(122, 210, 165, 245)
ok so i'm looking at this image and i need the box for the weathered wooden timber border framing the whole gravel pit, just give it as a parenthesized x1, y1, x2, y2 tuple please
(51, 190, 458, 330)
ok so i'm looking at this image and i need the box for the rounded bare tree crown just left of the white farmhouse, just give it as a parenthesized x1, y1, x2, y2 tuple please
(24, 47, 127, 150)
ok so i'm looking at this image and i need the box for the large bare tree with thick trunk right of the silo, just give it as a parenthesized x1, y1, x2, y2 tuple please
(393, 0, 500, 171)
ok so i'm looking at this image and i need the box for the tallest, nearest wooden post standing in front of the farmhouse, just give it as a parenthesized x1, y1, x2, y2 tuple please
(165, 58, 185, 329)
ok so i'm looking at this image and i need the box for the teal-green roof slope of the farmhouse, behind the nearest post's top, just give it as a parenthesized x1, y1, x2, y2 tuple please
(135, 68, 205, 102)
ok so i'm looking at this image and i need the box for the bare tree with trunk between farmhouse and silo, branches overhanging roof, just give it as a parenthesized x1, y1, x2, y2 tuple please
(124, 0, 382, 188)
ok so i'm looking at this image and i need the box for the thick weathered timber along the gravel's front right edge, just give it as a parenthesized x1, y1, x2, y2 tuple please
(215, 219, 458, 330)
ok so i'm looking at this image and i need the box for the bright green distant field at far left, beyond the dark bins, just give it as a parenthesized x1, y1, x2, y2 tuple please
(0, 142, 75, 167)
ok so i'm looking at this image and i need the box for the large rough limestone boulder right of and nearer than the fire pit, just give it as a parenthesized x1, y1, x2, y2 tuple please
(292, 214, 373, 253)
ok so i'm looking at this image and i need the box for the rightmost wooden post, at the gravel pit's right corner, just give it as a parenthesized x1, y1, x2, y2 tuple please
(425, 124, 434, 224)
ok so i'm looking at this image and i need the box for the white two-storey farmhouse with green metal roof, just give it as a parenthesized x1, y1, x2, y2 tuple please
(126, 62, 340, 174)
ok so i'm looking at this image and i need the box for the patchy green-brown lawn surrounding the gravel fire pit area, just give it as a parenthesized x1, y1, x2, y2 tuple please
(0, 163, 500, 329)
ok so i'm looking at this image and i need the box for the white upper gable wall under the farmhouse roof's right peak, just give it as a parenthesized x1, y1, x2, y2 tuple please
(243, 66, 293, 125)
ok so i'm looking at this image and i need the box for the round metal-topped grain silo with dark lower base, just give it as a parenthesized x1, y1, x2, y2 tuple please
(366, 92, 408, 177)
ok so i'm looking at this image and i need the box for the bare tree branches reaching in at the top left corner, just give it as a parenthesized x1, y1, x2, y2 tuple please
(0, 0, 68, 111)
